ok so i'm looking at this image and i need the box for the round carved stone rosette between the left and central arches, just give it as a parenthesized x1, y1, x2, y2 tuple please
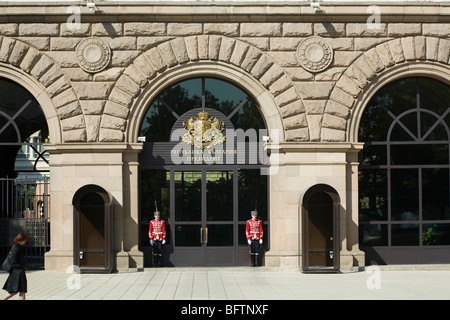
(76, 37, 111, 73)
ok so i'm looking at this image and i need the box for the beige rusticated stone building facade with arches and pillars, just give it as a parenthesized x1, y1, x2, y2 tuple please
(0, 1, 450, 271)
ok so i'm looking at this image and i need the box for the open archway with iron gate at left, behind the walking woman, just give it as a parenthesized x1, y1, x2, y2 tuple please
(0, 77, 50, 268)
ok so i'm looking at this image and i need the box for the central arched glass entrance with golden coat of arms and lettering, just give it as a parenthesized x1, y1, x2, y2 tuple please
(139, 77, 268, 266)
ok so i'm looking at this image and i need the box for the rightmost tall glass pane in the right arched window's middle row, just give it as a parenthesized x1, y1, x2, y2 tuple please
(422, 169, 450, 220)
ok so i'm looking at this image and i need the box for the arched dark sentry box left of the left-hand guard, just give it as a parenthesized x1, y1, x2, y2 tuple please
(72, 185, 114, 272)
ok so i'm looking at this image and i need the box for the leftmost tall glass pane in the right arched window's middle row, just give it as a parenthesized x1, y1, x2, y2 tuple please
(359, 170, 388, 221)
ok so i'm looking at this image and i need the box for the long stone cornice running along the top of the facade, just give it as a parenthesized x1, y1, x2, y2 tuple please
(0, 0, 450, 22)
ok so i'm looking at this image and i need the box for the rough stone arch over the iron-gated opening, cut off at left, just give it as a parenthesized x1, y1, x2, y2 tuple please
(0, 37, 86, 143)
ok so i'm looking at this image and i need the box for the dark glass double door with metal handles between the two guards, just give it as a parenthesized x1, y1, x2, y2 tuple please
(173, 169, 235, 266)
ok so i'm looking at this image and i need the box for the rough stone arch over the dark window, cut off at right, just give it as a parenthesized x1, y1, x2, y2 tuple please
(321, 36, 450, 142)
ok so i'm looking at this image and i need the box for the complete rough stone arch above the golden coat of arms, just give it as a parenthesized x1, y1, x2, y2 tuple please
(99, 35, 309, 142)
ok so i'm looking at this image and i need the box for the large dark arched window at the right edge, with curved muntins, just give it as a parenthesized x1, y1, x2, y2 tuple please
(359, 77, 450, 264)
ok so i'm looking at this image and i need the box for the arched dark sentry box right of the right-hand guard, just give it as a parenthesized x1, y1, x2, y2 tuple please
(302, 184, 340, 272)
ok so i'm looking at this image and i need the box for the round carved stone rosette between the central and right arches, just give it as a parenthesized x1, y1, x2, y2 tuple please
(297, 36, 333, 72)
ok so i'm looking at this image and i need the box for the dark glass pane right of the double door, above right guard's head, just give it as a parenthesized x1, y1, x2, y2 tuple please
(238, 169, 267, 221)
